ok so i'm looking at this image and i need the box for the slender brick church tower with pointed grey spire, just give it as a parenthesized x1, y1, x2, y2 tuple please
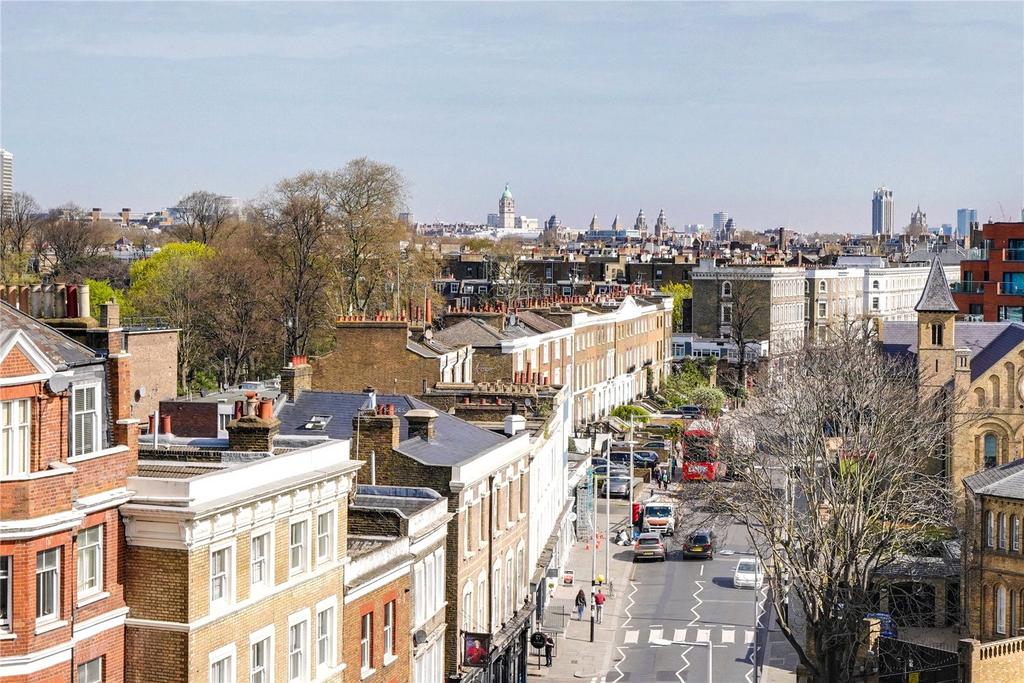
(914, 257, 958, 399)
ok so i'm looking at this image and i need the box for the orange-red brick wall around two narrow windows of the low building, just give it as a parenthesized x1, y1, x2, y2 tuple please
(342, 573, 413, 683)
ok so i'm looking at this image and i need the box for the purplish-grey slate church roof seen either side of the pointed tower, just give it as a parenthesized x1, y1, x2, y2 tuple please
(882, 321, 1024, 381)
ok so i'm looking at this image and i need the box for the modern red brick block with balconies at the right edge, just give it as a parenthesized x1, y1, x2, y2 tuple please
(953, 223, 1024, 323)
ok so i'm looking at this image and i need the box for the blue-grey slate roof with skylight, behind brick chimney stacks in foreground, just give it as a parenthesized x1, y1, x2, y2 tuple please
(278, 391, 506, 467)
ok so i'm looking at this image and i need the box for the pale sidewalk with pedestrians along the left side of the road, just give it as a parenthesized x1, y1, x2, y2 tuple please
(526, 486, 647, 681)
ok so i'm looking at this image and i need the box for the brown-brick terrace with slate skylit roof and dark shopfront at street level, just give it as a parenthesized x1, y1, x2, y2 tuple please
(279, 391, 534, 683)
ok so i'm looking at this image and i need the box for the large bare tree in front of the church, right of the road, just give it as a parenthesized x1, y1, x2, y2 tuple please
(725, 333, 955, 683)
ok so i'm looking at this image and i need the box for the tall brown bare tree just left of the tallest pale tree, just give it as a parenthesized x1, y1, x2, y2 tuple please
(253, 172, 332, 355)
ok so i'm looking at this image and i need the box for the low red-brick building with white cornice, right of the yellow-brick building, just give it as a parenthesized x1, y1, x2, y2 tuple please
(345, 485, 452, 683)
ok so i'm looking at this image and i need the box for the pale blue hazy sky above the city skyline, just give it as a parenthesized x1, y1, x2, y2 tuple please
(0, 1, 1024, 232)
